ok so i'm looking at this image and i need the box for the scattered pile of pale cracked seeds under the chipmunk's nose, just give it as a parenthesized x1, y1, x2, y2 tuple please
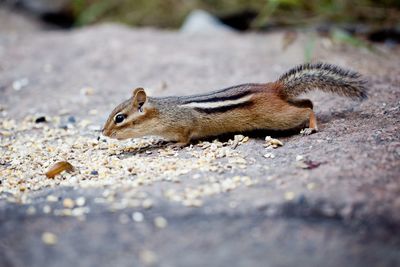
(0, 117, 257, 213)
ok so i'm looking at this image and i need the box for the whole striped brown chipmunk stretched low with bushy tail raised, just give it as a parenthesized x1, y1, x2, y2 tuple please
(102, 63, 367, 146)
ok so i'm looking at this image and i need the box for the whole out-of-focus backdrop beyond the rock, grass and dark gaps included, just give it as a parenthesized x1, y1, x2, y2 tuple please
(0, 0, 400, 45)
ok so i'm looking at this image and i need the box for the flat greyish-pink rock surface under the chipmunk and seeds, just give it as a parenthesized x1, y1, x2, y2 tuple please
(0, 21, 400, 267)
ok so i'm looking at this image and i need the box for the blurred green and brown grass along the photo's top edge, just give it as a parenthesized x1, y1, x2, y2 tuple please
(71, 0, 400, 29)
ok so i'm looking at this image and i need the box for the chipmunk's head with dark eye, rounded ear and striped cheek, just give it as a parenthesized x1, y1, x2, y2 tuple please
(102, 88, 159, 140)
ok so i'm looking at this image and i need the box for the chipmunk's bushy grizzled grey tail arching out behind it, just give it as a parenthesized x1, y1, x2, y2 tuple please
(278, 63, 367, 100)
